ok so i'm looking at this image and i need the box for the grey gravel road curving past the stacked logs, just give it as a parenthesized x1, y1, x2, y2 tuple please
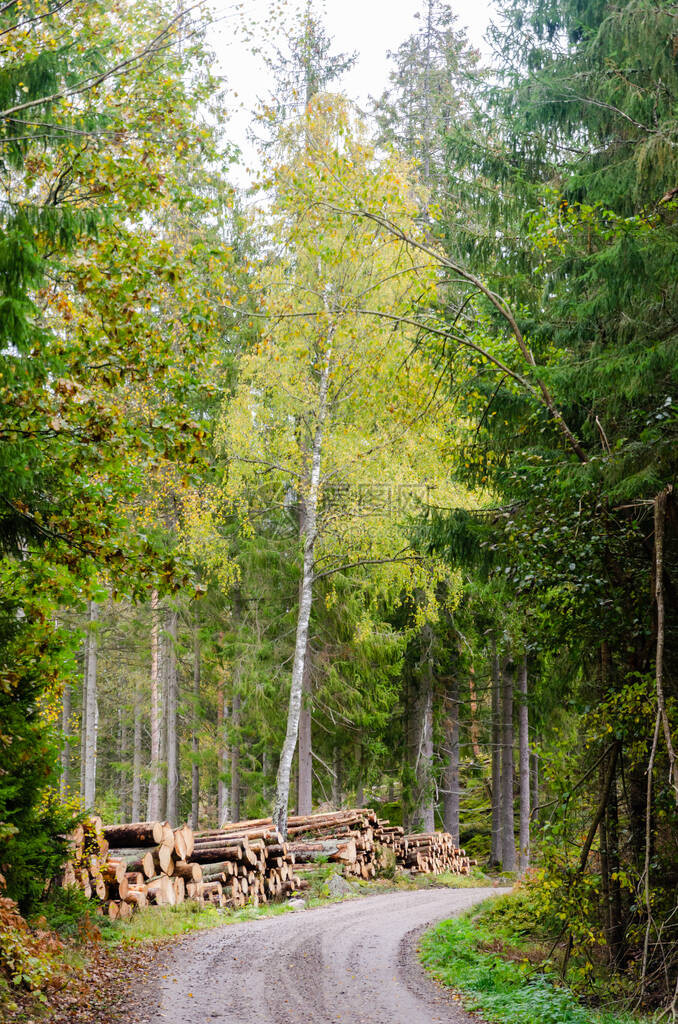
(150, 889, 502, 1024)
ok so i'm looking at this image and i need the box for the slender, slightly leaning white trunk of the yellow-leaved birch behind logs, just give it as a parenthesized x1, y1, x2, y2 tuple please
(272, 335, 332, 837)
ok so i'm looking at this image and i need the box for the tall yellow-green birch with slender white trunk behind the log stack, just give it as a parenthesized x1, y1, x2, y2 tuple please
(220, 95, 462, 833)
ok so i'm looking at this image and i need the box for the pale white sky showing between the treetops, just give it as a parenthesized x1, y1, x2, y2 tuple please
(210, 0, 492, 183)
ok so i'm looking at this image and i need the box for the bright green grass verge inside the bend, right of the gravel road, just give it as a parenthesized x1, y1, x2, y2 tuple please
(420, 897, 647, 1024)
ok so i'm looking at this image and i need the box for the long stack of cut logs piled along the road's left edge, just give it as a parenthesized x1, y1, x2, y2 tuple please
(59, 808, 475, 920)
